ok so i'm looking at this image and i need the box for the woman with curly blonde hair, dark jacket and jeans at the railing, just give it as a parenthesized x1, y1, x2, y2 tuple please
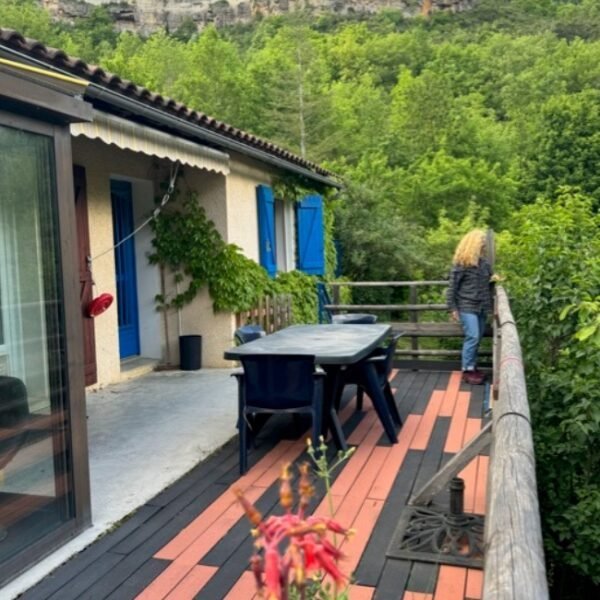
(447, 229, 492, 385)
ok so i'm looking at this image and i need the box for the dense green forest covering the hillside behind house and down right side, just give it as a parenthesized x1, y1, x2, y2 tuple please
(0, 0, 600, 598)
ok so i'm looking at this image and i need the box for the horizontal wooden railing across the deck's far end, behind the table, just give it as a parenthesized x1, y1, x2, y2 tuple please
(324, 281, 492, 362)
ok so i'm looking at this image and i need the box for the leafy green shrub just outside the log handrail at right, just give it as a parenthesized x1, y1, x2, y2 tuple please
(498, 189, 600, 598)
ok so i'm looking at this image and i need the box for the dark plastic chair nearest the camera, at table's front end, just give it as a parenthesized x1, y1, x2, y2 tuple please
(234, 354, 325, 475)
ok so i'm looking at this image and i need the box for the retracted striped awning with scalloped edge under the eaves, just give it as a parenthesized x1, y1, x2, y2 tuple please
(71, 110, 229, 175)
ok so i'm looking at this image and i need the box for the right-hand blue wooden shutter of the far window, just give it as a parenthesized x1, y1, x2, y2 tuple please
(296, 196, 325, 275)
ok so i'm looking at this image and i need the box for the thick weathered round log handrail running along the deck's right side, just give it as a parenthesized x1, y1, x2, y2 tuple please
(483, 286, 548, 600)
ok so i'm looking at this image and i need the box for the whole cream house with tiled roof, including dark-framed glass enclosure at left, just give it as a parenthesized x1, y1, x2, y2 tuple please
(0, 29, 339, 582)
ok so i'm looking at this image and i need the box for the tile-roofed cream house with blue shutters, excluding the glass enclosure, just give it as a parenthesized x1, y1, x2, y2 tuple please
(0, 30, 339, 385)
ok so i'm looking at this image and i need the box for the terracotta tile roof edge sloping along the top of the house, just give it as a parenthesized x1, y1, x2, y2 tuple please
(0, 28, 333, 177)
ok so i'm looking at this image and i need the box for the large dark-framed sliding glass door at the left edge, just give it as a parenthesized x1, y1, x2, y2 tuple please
(0, 120, 79, 568)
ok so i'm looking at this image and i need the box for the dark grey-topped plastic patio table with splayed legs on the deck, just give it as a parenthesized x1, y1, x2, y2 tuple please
(224, 324, 397, 449)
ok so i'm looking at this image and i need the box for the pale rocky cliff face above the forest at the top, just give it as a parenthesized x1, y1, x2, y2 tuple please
(39, 0, 476, 34)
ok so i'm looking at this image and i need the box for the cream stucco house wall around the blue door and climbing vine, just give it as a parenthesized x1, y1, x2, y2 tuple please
(73, 137, 292, 378)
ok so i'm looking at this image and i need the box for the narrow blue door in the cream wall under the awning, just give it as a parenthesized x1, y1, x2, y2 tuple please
(110, 181, 140, 358)
